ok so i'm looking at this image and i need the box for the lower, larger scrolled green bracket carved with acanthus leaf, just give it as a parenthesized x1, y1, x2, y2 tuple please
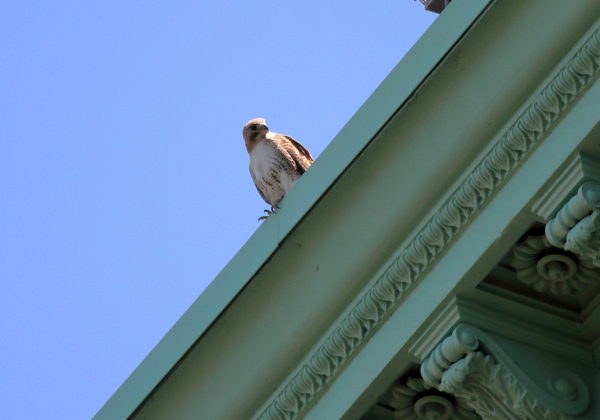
(421, 324, 590, 420)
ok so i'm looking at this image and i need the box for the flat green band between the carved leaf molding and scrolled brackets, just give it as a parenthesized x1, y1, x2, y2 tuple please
(306, 74, 600, 420)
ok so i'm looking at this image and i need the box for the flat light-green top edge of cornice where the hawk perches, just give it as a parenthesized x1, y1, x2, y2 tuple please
(94, 0, 492, 420)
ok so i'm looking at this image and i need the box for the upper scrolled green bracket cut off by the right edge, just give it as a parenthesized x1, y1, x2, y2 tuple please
(546, 182, 600, 267)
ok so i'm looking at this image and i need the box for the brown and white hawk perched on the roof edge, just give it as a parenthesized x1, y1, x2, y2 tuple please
(242, 118, 314, 219)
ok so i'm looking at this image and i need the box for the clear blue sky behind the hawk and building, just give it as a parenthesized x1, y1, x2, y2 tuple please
(0, 0, 437, 420)
